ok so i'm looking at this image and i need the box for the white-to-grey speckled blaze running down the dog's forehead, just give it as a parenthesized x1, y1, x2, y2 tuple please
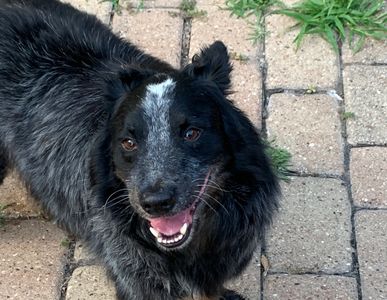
(141, 78, 175, 172)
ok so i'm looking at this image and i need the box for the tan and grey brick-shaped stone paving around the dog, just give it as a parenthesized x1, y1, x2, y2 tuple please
(0, 0, 387, 300)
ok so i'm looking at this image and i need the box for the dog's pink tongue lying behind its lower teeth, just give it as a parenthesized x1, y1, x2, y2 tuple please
(149, 209, 192, 236)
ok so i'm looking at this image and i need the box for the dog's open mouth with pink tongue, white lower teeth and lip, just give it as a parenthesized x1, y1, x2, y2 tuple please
(148, 171, 210, 248)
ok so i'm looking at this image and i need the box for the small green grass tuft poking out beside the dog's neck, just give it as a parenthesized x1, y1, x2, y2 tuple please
(265, 140, 292, 181)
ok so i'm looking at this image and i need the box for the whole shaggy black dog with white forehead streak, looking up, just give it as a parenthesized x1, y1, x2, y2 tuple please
(0, 0, 278, 300)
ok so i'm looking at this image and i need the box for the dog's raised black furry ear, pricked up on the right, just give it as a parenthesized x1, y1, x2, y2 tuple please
(184, 41, 232, 95)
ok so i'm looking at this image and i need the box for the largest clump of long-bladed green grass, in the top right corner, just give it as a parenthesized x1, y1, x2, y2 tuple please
(273, 0, 387, 52)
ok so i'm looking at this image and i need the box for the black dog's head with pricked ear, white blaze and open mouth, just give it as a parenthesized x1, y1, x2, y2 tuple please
(108, 42, 276, 250)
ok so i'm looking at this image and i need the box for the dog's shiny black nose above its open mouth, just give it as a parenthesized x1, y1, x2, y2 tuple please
(140, 187, 176, 216)
